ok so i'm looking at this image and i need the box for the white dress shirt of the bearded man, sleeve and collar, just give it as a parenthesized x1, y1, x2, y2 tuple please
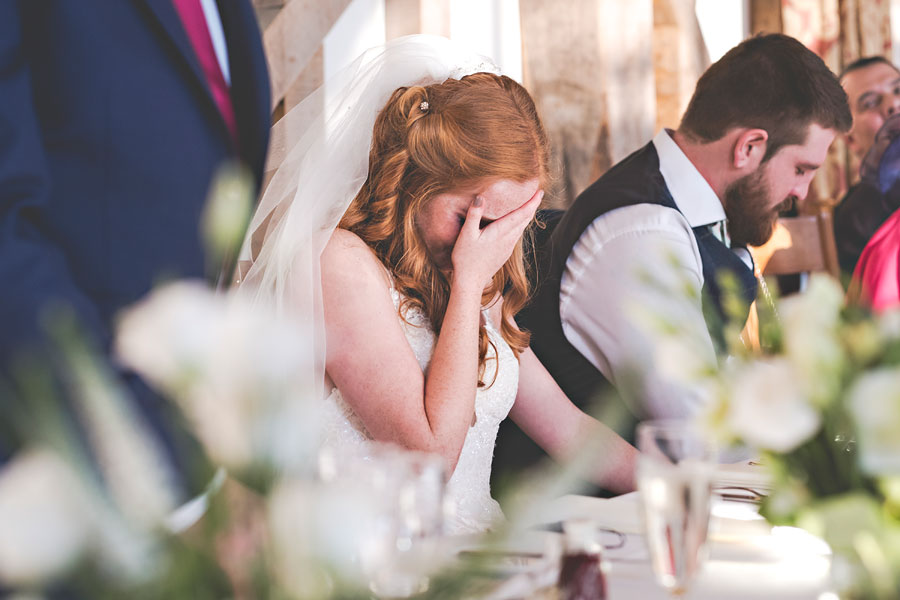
(559, 130, 749, 418)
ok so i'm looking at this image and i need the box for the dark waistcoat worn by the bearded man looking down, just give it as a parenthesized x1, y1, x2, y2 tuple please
(494, 143, 757, 488)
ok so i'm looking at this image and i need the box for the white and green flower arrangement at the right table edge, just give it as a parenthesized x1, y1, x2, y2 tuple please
(690, 275, 900, 598)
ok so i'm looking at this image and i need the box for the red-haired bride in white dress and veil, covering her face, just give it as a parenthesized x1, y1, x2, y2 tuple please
(240, 36, 636, 533)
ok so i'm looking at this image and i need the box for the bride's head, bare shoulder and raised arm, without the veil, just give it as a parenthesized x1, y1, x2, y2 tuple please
(310, 73, 548, 471)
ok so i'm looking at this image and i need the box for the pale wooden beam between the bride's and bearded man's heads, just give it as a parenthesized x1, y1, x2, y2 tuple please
(519, 0, 656, 207)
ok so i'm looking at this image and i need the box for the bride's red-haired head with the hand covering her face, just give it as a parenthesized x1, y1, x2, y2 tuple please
(340, 73, 549, 376)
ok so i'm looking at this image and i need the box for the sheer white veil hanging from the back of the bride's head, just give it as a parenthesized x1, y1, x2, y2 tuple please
(233, 35, 499, 406)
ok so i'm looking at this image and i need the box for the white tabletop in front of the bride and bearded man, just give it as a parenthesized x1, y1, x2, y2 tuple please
(458, 467, 837, 600)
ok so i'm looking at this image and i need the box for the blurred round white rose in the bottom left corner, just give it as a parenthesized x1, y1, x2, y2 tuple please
(0, 449, 92, 586)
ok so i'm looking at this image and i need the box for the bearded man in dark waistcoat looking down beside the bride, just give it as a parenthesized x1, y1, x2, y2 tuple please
(494, 34, 851, 476)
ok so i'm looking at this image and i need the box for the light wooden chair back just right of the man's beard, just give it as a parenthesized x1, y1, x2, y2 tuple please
(750, 208, 841, 278)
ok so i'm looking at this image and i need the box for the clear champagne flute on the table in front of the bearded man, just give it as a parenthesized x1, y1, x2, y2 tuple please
(637, 421, 716, 597)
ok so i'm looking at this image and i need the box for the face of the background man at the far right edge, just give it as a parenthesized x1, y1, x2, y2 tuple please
(841, 63, 900, 158)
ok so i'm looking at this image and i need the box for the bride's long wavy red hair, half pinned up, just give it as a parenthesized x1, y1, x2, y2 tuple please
(339, 73, 549, 385)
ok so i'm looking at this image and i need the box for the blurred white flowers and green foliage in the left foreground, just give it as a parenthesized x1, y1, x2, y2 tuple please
(0, 165, 500, 600)
